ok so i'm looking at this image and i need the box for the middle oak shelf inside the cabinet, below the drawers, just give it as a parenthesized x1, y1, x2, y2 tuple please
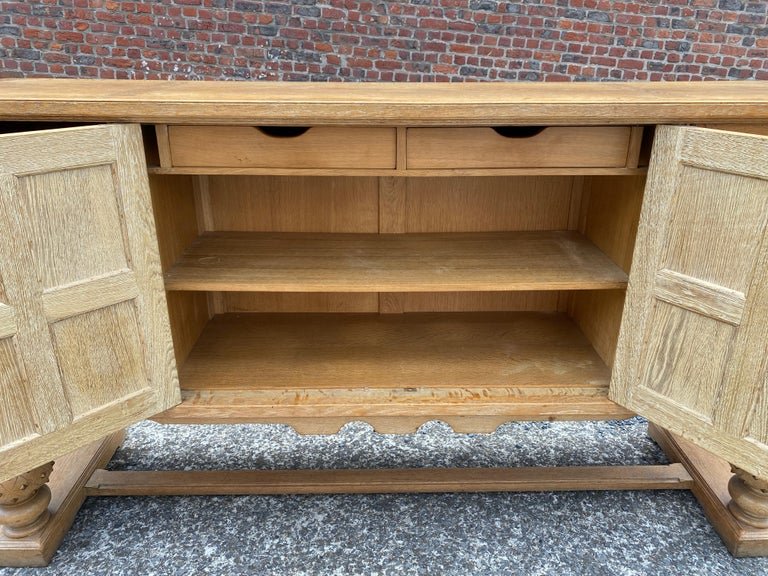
(165, 231, 627, 292)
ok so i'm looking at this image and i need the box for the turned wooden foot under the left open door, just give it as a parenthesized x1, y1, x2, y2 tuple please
(0, 462, 53, 539)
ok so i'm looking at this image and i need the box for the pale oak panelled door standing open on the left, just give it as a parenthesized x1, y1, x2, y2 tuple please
(0, 126, 179, 481)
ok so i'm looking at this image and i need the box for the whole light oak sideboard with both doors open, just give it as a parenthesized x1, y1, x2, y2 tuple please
(0, 80, 768, 565)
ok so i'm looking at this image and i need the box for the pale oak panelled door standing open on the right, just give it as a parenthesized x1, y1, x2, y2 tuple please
(611, 126, 768, 479)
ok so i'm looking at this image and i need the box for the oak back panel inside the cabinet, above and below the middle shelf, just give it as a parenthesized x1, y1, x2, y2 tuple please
(201, 176, 582, 313)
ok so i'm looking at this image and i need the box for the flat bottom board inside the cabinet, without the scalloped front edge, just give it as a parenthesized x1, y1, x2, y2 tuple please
(182, 312, 607, 390)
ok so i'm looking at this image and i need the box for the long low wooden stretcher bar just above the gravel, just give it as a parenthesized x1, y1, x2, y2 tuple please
(87, 464, 692, 496)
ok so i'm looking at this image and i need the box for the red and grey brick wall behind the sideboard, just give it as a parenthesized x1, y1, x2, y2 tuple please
(0, 0, 768, 81)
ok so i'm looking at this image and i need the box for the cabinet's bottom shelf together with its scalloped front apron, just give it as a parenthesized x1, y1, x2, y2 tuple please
(156, 312, 632, 433)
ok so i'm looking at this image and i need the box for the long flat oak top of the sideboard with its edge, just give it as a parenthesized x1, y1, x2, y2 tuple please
(0, 79, 768, 126)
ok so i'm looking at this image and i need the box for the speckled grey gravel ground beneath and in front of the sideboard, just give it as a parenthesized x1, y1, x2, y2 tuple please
(0, 418, 768, 576)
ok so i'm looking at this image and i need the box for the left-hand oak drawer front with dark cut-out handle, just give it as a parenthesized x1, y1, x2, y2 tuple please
(168, 126, 397, 169)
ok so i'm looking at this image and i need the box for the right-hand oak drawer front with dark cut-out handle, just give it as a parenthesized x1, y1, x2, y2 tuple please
(407, 126, 632, 169)
